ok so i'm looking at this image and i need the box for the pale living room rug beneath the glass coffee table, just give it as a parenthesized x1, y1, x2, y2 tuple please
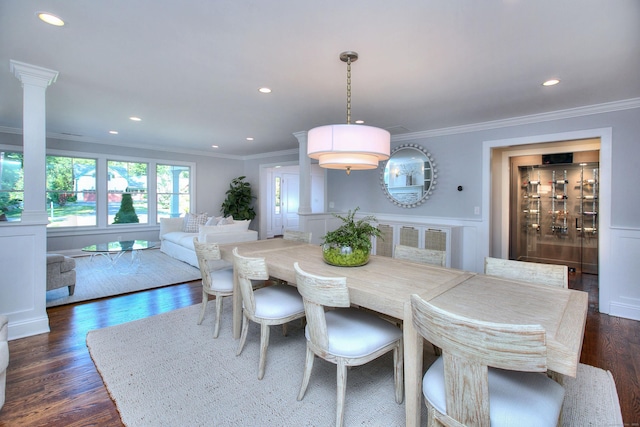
(47, 249, 202, 307)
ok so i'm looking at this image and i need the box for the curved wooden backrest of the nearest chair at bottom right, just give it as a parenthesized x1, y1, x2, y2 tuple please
(411, 294, 547, 426)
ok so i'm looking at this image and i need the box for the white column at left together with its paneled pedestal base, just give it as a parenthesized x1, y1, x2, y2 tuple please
(0, 60, 58, 339)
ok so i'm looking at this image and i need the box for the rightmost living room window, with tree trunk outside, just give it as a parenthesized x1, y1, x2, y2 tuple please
(156, 165, 191, 222)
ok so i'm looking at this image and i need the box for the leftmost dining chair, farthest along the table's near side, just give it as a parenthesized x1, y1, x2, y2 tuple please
(193, 237, 238, 338)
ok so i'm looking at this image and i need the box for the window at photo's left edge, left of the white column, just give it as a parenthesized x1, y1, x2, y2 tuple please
(0, 151, 24, 221)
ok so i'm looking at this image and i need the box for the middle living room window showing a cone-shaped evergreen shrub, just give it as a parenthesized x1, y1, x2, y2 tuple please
(107, 160, 149, 224)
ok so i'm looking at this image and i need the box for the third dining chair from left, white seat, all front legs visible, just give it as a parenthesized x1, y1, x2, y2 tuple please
(294, 262, 404, 426)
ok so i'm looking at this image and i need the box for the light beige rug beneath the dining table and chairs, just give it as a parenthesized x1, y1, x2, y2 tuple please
(87, 301, 622, 427)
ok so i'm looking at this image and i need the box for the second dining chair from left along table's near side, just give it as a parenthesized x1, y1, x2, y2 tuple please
(233, 248, 305, 380)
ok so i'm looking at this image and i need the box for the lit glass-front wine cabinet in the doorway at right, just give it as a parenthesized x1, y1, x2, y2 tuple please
(510, 162, 599, 274)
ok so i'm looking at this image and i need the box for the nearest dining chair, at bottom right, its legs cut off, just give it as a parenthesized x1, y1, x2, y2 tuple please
(411, 294, 564, 427)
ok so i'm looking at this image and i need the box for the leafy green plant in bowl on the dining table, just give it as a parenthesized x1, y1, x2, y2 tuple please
(322, 207, 382, 267)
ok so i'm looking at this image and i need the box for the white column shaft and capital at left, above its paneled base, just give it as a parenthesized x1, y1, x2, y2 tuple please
(10, 60, 58, 224)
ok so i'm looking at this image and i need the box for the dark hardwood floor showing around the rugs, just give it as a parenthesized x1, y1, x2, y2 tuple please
(0, 274, 640, 427)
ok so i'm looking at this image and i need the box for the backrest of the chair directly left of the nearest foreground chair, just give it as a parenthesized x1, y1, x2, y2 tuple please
(293, 262, 350, 350)
